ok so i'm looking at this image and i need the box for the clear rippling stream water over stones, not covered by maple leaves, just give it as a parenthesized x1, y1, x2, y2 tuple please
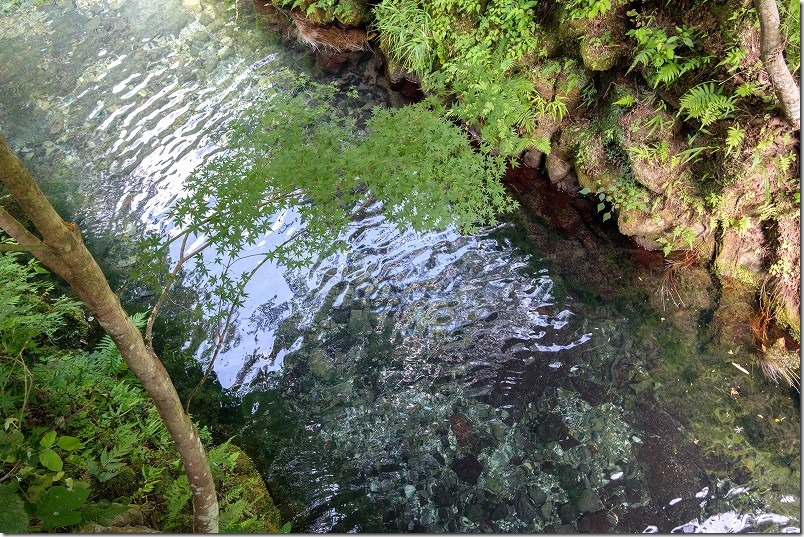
(0, 0, 801, 532)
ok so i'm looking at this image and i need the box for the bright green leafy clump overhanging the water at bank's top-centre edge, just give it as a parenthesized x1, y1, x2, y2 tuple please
(374, 0, 546, 155)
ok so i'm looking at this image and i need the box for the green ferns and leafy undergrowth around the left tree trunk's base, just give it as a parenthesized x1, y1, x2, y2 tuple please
(0, 250, 278, 532)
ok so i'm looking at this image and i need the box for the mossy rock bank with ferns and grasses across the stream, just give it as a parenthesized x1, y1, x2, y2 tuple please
(258, 0, 800, 386)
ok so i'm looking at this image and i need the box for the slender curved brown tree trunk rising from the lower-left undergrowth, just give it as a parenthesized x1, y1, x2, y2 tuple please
(0, 135, 218, 533)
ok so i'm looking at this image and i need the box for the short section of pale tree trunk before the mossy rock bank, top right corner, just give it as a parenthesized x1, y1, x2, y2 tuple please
(756, 0, 801, 129)
